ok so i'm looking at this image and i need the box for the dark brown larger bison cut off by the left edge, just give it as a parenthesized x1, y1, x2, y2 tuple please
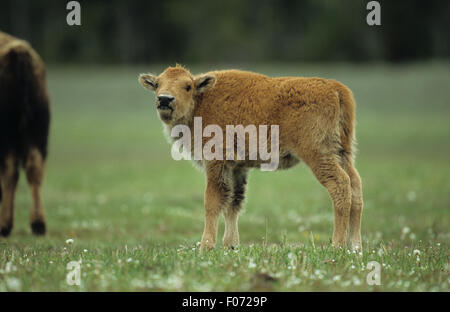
(0, 32, 50, 236)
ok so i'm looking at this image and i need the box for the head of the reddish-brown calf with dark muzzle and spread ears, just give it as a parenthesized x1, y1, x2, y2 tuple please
(139, 65, 216, 124)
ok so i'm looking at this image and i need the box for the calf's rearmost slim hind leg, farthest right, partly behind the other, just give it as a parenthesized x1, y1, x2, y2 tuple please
(343, 160, 363, 250)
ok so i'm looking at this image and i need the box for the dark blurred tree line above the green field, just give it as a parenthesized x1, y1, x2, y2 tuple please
(0, 0, 450, 63)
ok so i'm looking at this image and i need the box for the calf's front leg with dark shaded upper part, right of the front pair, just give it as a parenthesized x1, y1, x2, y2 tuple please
(223, 168, 247, 248)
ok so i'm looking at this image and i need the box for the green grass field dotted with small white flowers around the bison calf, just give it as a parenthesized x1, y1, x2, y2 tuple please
(0, 62, 450, 291)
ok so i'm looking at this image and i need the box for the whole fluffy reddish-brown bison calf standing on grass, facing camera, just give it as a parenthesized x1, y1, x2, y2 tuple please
(139, 65, 363, 249)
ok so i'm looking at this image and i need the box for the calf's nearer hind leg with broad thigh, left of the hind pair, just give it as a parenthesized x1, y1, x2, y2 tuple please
(305, 154, 352, 246)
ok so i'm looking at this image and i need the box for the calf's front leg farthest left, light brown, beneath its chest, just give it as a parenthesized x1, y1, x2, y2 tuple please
(200, 162, 230, 251)
